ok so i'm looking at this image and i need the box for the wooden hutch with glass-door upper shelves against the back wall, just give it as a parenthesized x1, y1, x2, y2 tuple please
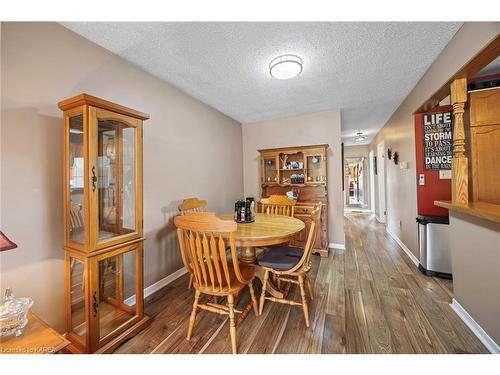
(258, 144, 328, 256)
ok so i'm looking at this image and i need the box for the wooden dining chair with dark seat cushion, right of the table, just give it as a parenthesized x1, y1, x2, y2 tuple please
(258, 203, 321, 327)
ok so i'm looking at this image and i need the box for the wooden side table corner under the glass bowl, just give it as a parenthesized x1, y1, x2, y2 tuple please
(0, 312, 69, 354)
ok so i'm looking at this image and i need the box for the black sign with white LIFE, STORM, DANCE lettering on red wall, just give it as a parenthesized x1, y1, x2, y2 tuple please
(423, 112, 453, 169)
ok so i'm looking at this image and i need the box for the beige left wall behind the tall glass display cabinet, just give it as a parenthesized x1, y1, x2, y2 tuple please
(0, 22, 243, 331)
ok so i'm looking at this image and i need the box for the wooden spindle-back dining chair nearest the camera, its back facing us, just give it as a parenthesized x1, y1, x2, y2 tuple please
(174, 212, 259, 354)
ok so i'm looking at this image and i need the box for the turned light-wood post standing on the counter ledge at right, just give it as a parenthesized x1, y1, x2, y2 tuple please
(450, 78, 469, 206)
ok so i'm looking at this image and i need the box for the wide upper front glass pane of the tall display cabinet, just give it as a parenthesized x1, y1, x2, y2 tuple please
(91, 110, 138, 247)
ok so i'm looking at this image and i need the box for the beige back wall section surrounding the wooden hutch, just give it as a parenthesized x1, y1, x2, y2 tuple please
(243, 110, 344, 248)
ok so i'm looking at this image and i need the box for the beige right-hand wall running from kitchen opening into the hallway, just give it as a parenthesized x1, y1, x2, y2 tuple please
(370, 22, 500, 256)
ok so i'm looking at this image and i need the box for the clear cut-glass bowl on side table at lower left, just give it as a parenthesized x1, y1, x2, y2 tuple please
(0, 297, 33, 337)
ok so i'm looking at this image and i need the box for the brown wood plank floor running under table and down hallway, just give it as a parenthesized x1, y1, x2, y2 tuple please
(115, 213, 487, 353)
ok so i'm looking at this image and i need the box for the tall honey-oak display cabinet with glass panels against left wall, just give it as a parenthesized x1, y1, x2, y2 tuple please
(59, 94, 149, 353)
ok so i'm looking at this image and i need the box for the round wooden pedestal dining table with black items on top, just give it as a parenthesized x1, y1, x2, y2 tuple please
(218, 213, 305, 298)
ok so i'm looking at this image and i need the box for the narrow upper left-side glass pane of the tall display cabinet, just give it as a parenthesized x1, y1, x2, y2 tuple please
(66, 113, 86, 246)
